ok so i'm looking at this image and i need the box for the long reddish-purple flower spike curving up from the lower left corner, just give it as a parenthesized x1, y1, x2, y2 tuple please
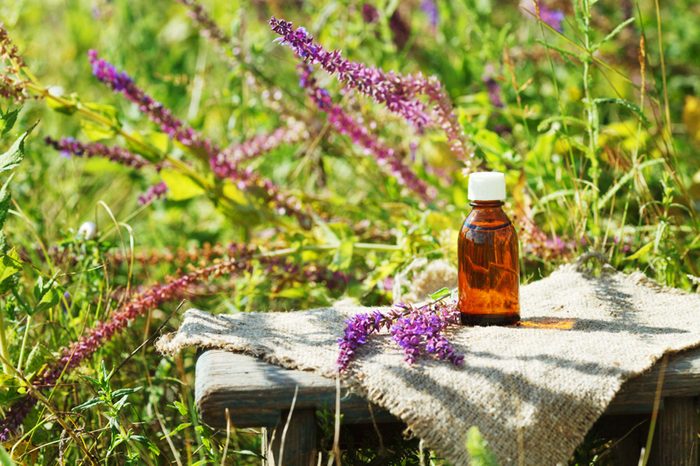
(0, 251, 254, 442)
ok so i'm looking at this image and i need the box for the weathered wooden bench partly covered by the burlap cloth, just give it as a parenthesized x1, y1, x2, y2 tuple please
(195, 348, 700, 466)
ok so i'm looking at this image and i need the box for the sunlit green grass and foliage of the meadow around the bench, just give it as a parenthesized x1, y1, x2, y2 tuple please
(0, 0, 700, 464)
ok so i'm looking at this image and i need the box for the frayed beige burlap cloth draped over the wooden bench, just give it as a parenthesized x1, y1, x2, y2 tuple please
(158, 266, 700, 466)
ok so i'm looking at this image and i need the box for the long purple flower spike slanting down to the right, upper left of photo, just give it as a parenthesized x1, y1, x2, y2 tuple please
(88, 50, 310, 225)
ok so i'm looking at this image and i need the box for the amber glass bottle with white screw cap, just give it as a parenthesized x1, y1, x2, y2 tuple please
(458, 172, 520, 325)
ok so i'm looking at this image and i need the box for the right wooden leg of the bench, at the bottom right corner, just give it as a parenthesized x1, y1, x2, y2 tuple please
(651, 397, 700, 466)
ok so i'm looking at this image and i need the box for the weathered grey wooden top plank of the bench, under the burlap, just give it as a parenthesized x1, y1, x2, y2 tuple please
(195, 349, 700, 427)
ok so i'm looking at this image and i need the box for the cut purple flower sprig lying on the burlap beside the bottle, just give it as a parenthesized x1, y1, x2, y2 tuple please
(337, 302, 464, 372)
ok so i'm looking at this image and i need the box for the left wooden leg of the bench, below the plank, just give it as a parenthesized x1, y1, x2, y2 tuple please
(270, 409, 318, 466)
